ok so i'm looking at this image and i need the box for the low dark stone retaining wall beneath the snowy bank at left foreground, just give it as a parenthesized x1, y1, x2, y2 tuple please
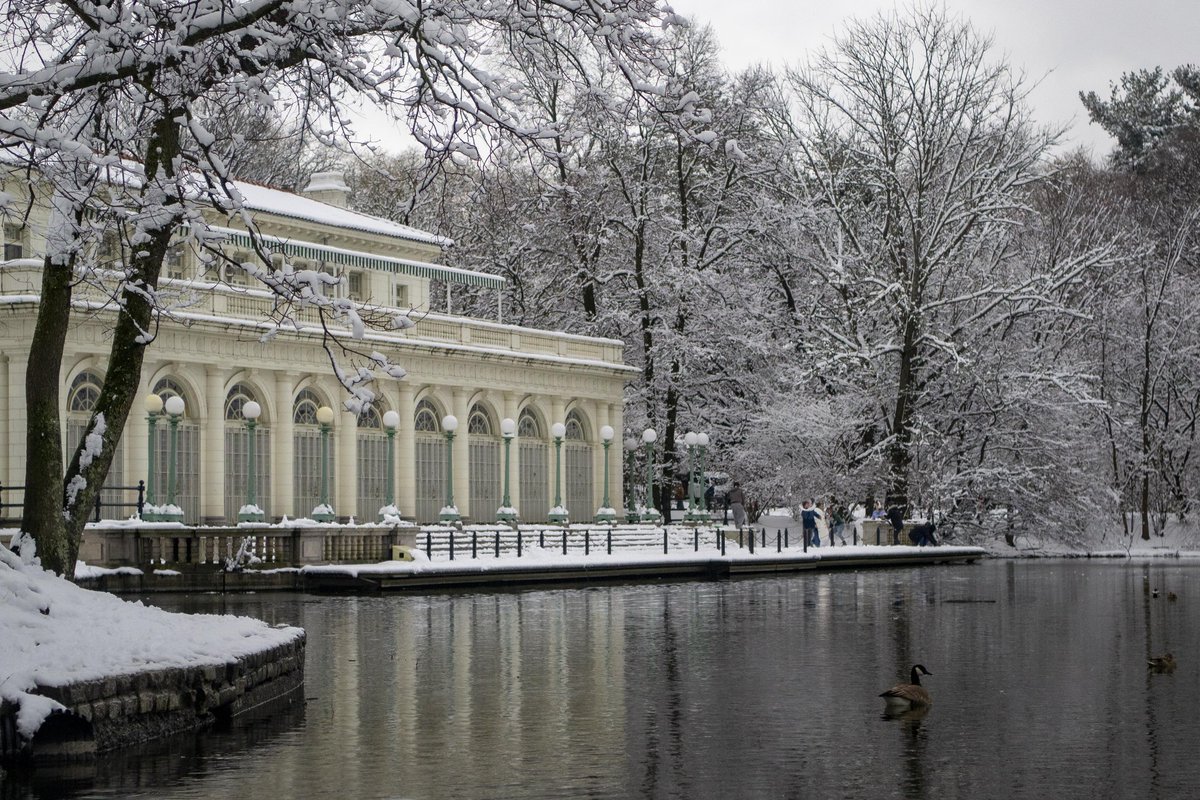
(0, 632, 305, 762)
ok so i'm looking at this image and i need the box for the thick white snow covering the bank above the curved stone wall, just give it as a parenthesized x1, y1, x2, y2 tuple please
(0, 545, 302, 738)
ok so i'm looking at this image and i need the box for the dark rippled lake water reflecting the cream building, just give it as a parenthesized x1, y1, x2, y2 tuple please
(9, 560, 1200, 800)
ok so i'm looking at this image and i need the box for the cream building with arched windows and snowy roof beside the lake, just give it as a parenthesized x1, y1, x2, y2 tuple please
(0, 167, 631, 524)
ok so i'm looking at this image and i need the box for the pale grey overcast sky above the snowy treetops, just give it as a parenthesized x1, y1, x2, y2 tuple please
(671, 0, 1200, 156)
